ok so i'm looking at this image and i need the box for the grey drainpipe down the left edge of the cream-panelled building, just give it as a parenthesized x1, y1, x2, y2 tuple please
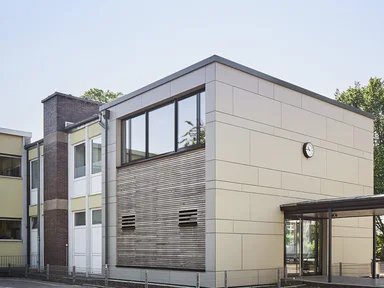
(99, 110, 110, 265)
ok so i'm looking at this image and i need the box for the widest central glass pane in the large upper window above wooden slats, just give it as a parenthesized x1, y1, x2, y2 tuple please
(148, 103, 175, 157)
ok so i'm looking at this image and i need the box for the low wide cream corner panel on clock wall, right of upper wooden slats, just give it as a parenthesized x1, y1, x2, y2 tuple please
(216, 161, 259, 185)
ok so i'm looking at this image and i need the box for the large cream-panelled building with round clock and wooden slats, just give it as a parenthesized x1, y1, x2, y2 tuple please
(100, 56, 373, 287)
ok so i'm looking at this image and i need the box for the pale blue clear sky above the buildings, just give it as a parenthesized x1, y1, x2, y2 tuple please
(0, 0, 384, 141)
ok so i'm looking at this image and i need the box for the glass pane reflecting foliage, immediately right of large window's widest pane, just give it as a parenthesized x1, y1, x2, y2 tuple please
(177, 95, 197, 148)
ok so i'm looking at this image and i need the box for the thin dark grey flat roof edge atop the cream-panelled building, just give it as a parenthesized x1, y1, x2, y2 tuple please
(100, 55, 375, 119)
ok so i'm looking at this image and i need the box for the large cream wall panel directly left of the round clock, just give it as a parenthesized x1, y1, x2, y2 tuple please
(251, 132, 302, 173)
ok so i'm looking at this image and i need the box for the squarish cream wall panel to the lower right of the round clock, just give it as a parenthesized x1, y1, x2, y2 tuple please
(327, 150, 359, 184)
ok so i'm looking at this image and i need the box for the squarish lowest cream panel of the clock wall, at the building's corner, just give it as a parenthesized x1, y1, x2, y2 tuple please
(216, 234, 242, 271)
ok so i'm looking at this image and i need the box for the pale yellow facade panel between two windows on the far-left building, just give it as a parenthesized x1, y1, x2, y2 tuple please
(0, 177, 23, 218)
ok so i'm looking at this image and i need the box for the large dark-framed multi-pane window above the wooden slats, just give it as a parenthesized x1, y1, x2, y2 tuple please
(122, 92, 205, 163)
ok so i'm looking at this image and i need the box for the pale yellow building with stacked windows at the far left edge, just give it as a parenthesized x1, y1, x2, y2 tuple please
(0, 128, 32, 264)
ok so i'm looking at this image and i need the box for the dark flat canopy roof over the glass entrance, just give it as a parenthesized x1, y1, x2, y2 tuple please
(280, 194, 384, 219)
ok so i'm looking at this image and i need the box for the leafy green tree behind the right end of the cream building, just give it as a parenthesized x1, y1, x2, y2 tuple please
(335, 78, 384, 260)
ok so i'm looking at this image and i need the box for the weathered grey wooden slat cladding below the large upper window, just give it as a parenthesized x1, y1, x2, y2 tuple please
(117, 149, 205, 270)
